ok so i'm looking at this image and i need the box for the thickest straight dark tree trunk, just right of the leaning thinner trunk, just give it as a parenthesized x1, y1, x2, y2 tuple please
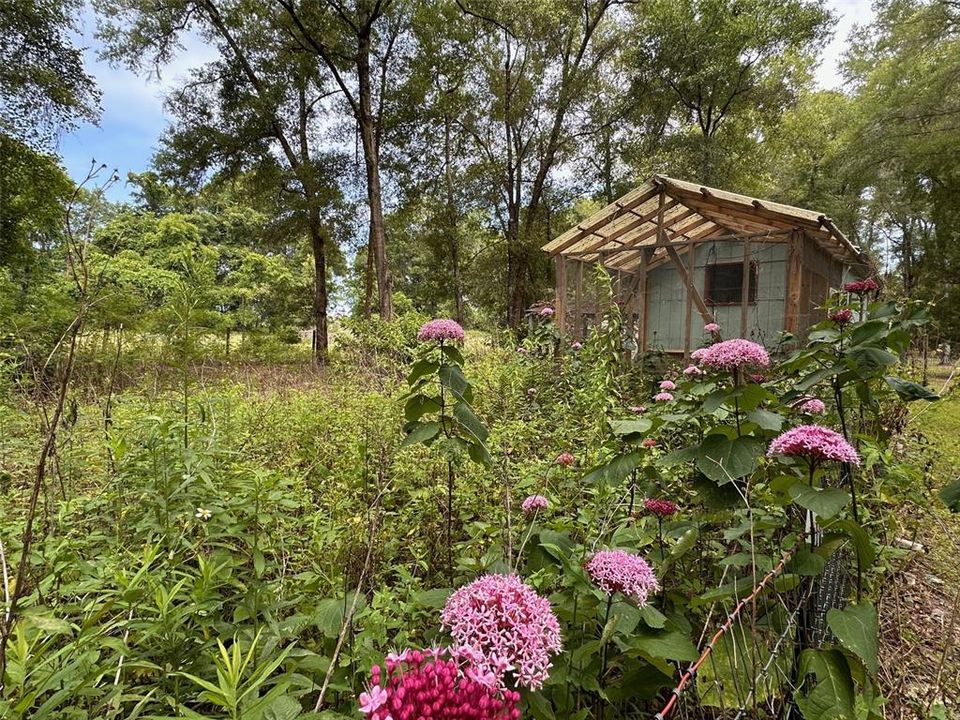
(357, 30, 393, 320)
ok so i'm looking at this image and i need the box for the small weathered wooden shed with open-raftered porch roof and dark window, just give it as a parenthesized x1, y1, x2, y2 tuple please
(543, 175, 869, 355)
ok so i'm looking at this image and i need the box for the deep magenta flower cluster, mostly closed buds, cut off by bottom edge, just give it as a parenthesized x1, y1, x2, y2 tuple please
(359, 648, 520, 720)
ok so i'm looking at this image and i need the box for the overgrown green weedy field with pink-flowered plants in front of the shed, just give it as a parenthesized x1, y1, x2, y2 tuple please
(0, 296, 955, 720)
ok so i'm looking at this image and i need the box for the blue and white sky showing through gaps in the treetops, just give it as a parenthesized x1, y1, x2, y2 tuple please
(59, 0, 873, 201)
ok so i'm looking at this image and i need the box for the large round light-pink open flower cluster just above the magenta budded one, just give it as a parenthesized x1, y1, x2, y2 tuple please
(441, 575, 561, 690)
